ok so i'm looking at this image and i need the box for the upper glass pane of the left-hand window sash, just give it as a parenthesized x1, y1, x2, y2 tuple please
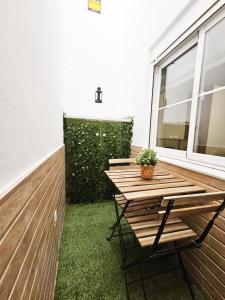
(159, 46, 196, 107)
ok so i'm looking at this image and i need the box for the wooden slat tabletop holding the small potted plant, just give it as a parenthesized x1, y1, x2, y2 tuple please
(105, 167, 205, 201)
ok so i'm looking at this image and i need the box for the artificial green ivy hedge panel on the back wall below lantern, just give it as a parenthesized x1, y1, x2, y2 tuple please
(64, 118, 133, 203)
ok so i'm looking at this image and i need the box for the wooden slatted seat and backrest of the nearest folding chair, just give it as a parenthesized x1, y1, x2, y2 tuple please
(131, 192, 225, 247)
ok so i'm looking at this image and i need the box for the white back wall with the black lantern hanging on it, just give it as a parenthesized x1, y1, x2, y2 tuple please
(63, 0, 189, 147)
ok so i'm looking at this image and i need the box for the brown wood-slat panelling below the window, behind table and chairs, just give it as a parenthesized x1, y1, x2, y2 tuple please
(131, 146, 225, 300)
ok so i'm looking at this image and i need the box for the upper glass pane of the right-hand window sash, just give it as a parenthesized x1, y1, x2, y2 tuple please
(200, 19, 225, 93)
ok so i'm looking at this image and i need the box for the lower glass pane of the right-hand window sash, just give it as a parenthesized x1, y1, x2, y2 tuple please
(194, 91, 225, 156)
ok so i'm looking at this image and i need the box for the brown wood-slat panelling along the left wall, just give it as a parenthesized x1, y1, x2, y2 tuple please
(0, 147, 65, 300)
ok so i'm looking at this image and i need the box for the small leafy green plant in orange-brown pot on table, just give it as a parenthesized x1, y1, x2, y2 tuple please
(136, 149, 158, 179)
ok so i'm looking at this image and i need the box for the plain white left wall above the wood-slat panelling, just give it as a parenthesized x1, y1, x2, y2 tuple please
(0, 0, 63, 195)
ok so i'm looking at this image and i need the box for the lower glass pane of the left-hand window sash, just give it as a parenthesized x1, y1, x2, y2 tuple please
(157, 101, 191, 151)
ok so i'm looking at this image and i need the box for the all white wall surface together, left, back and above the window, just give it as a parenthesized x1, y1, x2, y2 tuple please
(0, 0, 219, 195)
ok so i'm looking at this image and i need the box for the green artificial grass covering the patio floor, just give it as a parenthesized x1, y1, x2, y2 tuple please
(55, 202, 205, 300)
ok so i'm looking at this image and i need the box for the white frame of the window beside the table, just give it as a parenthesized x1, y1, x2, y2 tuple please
(150, 10, 225, 171)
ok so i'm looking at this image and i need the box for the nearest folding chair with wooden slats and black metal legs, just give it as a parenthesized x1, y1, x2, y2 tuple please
(123, 191, 225, 299)
